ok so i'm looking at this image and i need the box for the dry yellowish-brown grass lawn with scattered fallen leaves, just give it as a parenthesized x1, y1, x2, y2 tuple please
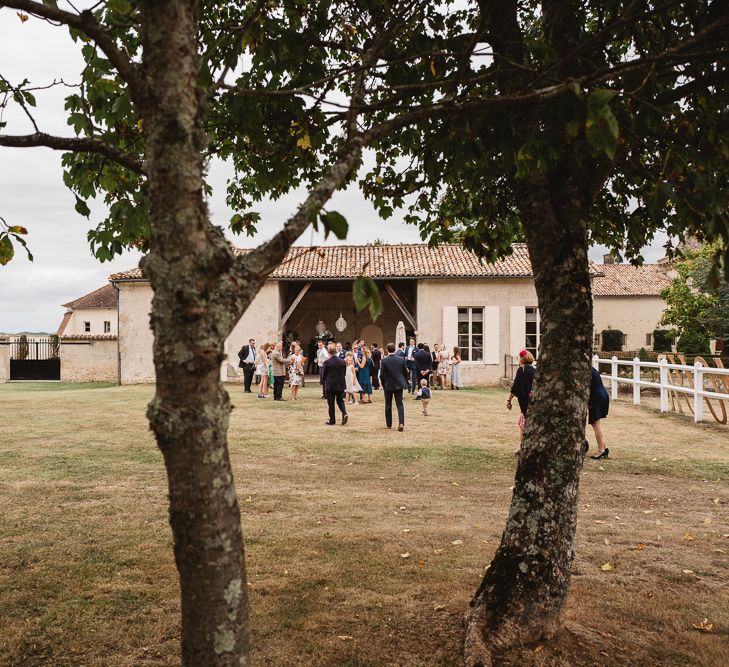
(0, 384, 729, 667)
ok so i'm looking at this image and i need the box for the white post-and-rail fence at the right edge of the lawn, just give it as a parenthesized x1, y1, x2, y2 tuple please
(592, 355, 729, 422)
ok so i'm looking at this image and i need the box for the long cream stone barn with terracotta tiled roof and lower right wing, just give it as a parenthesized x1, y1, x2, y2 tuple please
(110, 244, 669, 385)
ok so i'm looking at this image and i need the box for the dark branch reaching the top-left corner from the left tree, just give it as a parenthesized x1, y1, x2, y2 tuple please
(0, 0, 144, 101)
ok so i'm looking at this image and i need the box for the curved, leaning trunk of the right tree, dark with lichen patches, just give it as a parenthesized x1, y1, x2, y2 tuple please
(464, 175, 592, 667)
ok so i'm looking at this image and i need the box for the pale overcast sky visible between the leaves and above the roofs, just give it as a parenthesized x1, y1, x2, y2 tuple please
(0, 9, 664, 333)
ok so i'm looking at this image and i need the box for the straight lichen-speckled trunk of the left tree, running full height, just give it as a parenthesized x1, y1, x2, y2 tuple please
(139, 0, 248, 667)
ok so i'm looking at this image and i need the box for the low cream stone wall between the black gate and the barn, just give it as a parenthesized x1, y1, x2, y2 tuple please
(61, 336, 118, 382)
